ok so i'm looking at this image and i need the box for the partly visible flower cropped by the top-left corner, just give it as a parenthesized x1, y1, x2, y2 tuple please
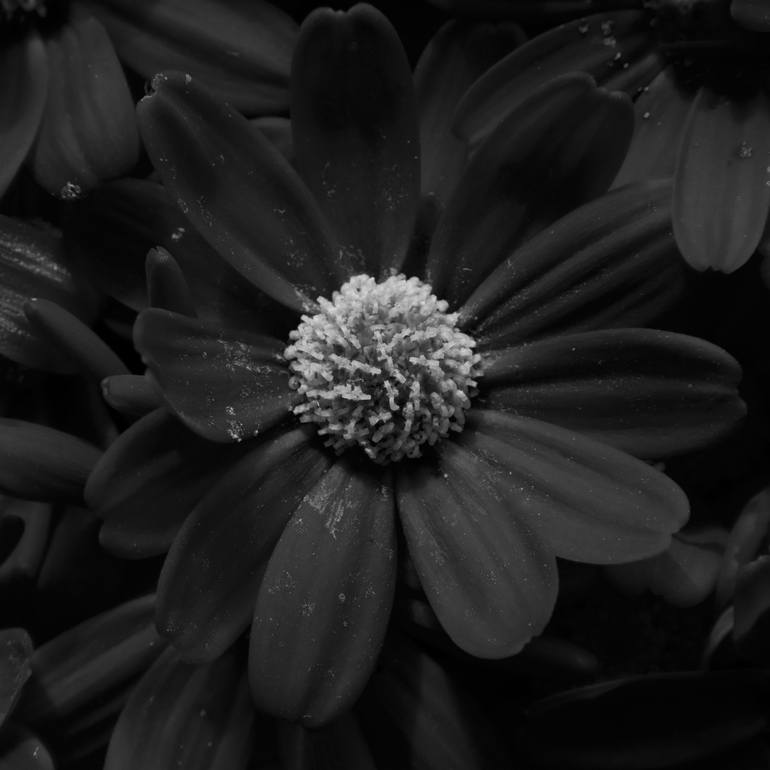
(0, 0, 296, 199)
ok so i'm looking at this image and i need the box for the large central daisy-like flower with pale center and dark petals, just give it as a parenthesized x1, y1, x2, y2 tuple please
(87, 6, 742, 725)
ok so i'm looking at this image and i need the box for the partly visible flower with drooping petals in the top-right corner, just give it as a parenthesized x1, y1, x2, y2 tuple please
(448, 0, 770, 272)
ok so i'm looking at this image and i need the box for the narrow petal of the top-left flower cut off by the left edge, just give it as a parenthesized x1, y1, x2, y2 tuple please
(0, 34, 48, 197)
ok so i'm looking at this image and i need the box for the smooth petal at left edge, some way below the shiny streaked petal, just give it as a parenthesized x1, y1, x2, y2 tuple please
(0, 418, 101, 503)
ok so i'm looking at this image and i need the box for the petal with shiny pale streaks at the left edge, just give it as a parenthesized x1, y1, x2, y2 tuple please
(0, 216, 91, 371)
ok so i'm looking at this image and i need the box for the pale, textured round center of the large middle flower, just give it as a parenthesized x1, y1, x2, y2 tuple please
(284, 275, 481, 465)
